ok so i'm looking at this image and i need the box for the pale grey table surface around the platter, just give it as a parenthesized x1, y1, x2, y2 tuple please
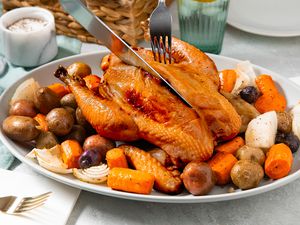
(8, 1, 300, 225)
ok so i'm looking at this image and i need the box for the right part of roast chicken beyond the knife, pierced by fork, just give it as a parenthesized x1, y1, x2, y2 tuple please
(138, 38, 241, 139)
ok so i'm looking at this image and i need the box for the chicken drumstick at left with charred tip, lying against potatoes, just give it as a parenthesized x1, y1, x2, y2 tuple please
(55, 67, 140, 141)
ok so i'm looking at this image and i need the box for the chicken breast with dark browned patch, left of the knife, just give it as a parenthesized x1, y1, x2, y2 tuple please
(99, 55, 214, 163)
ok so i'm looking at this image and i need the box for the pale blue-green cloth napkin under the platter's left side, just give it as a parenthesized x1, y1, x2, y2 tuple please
(0, 23, 82, 169)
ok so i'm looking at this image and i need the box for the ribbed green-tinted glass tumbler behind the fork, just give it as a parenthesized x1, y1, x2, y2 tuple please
(177, 0, 229, 54)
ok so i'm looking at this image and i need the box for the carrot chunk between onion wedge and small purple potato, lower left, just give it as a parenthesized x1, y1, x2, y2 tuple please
(61, 140, 83, 168)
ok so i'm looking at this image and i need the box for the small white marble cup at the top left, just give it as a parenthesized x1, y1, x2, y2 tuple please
(0, 7, 58, 67)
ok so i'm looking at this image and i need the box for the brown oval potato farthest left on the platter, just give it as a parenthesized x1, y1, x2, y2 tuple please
(2, 116, 40, 142)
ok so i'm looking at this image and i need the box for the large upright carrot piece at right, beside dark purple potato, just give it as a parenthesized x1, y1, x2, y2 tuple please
(254, 74, 287, 113)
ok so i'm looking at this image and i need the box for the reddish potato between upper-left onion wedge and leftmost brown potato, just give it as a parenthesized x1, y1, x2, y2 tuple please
(8, 99, 37, 117)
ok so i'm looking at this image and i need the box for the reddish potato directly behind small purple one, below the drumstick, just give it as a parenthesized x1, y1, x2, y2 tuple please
(83, 134, 116, 159)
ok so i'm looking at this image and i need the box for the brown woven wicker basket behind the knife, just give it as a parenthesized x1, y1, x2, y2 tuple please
(2, 0, 172, 45)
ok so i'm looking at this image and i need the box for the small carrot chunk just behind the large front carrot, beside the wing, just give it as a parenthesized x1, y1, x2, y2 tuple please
(106, 148, 128, 168)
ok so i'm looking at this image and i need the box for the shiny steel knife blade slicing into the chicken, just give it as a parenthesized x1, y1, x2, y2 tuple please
(60, 0, 192, 107)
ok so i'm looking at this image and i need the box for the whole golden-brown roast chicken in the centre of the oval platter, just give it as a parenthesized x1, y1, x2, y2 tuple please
(55, 38, 241, 164)
